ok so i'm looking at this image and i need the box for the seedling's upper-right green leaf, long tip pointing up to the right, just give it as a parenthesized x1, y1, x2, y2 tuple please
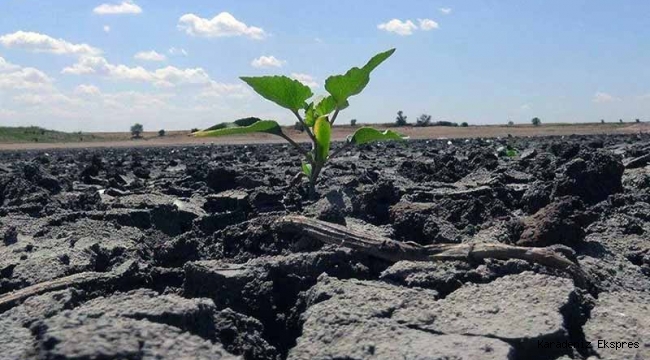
(325, 49, 395, 110)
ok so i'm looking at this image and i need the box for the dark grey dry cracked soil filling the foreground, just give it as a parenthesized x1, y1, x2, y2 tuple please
(0, 135, 650, 360)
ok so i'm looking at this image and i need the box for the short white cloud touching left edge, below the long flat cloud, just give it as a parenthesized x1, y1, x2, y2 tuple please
(0, 57, 54, 91)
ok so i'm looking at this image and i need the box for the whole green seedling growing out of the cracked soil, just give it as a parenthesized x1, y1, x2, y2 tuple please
(193, 49, 406, 196)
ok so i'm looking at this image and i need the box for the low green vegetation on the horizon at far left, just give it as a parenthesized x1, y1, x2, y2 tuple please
(0, 126, 101, 143)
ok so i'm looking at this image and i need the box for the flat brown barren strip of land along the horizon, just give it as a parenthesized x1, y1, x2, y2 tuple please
(0, 123, 650, 150)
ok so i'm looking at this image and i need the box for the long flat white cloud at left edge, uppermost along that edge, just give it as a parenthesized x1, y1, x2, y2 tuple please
(0, 31, 102, 55)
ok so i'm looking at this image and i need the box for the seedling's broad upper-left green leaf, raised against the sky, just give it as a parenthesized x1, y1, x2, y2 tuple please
(241, 76, 314, 111)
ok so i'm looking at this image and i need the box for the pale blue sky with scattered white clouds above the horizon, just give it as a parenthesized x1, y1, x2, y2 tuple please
(0, 0, 650, 131)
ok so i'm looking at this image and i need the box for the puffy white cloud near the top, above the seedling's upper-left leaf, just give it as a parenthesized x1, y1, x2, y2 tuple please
(178, 12, 267, 40)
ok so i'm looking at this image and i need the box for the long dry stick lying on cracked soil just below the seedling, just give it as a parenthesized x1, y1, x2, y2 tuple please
(275, 216, 593, 288)
